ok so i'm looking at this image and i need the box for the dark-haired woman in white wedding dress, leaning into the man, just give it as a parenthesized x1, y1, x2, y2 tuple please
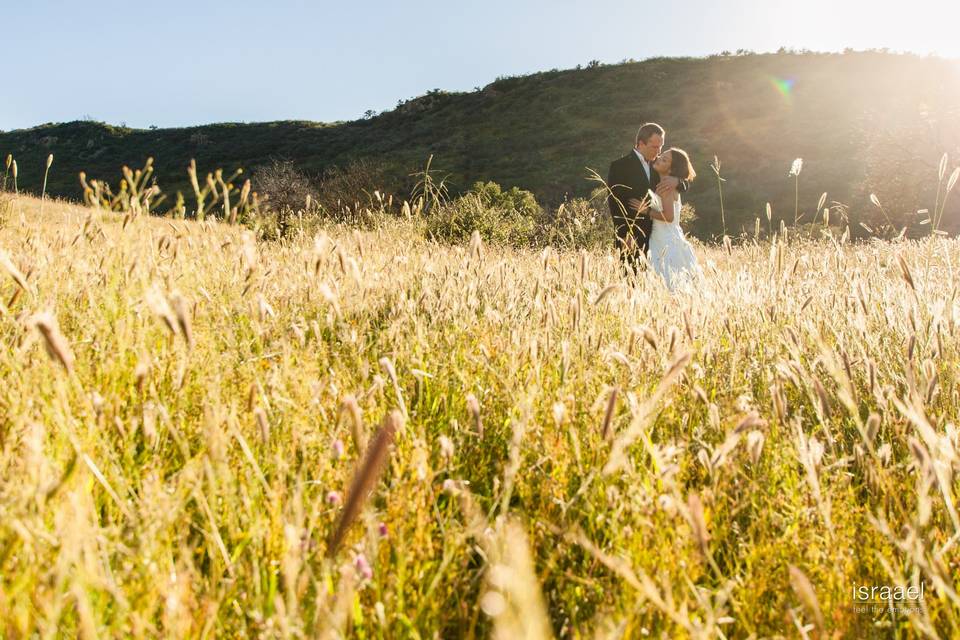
(649, 148, 703, 291)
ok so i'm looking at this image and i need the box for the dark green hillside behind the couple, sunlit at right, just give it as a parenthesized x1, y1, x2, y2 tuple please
(0, 52, 960, 234)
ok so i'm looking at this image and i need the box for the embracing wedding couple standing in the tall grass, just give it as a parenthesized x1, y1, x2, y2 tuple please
(607, 122, 702, 291)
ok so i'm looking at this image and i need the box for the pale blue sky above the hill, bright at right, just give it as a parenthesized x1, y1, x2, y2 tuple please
(0, 0, 960, 130)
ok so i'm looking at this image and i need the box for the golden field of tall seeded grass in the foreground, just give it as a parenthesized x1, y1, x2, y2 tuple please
(0, 196, 960, 639)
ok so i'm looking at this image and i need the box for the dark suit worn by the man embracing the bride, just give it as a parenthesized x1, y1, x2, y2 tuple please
(607, 149, 660, 271)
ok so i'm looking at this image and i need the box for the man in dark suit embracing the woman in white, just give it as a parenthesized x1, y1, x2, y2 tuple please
(607, 122, 686, 275)
